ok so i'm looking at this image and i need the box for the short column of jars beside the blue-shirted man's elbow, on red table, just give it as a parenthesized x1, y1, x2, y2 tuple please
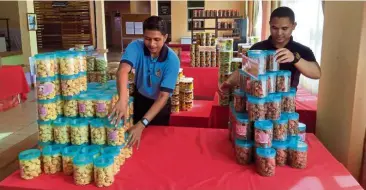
(175, 77, 193, 111)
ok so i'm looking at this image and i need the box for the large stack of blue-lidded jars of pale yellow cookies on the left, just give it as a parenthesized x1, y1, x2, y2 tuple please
(19, 47, 133, 187)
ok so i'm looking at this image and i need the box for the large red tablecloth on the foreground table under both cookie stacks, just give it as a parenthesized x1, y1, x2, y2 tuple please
(0, 127, 362, 190)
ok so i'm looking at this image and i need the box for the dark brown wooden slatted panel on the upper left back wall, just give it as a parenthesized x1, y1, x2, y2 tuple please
(34, 1, 92, 49)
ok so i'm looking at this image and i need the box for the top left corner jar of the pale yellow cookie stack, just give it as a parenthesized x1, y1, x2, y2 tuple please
(34, 54, 55, 77)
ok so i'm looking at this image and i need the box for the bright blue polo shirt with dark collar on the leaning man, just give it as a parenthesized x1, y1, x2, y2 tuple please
(121, 40, 180, 100)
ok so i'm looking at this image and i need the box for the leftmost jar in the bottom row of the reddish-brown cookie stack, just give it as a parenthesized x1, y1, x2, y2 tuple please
(235, 139, 253, 165)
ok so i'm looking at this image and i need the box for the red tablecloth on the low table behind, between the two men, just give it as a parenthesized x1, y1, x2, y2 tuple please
(170, 100, 213, 127)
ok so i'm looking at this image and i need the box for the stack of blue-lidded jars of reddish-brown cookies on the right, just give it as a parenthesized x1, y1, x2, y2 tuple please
(229, 50, 308, 177)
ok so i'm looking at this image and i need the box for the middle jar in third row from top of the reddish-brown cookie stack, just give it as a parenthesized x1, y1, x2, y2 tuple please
(266, 94, 281, 120)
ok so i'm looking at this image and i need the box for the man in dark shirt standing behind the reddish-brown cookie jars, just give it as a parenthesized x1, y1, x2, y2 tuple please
(220, 7, 321, 90)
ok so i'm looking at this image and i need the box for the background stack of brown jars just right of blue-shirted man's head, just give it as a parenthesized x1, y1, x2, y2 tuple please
(191, 32, 218, 67)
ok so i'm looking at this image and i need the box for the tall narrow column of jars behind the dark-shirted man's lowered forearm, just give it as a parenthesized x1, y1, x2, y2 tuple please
(217, 38, 234, 106)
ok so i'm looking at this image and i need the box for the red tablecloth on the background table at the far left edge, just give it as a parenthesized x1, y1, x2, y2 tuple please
(0, 66, 30, 101)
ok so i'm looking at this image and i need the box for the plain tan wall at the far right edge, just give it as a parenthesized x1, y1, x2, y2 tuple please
(316, 1, 366, 179)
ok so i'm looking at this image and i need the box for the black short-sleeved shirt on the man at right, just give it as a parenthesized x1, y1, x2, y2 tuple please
(250, 36, 316, 88)
